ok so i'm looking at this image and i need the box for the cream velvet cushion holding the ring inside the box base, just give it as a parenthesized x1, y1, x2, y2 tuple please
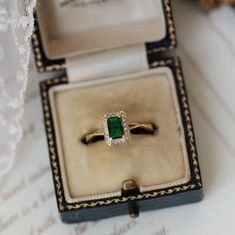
(50, 68, 190, 201)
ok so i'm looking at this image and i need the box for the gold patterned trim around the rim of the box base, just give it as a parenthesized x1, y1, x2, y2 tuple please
(41, 59, 202, 212)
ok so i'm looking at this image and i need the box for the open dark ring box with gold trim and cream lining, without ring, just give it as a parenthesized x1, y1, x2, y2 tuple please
(32, 0, 203, 223)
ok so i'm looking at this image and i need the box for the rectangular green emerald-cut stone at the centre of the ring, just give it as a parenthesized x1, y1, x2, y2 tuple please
(107, 117, 124, 140)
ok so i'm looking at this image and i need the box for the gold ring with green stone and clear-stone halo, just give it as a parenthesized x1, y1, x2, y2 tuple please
(82, 111, 158, 146)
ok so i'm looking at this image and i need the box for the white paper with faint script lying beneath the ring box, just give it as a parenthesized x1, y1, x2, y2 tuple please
(0, 0, 235, 235)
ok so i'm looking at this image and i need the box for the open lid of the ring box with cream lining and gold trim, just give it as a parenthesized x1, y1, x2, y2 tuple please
(32, 0, 176, 72)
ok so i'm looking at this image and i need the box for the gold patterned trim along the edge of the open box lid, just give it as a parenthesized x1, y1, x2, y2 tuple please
(32, 0, 176, 73)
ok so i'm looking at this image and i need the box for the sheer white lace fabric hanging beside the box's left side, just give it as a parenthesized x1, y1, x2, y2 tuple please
(0, 0, 36, 176)
